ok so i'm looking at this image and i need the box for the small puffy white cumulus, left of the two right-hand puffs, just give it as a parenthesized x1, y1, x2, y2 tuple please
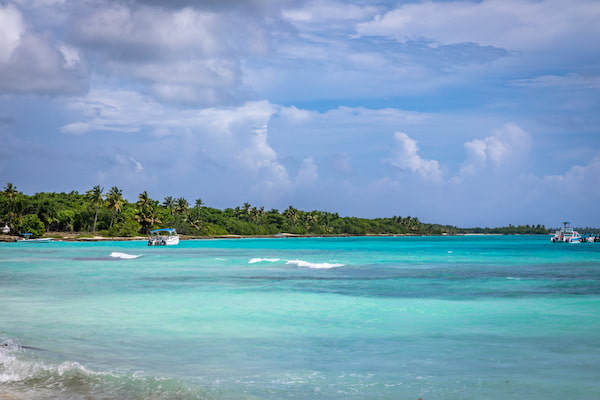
(388, 132, 443, 181)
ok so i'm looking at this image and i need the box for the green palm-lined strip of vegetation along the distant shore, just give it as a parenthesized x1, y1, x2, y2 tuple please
(0, 183, 548, 237)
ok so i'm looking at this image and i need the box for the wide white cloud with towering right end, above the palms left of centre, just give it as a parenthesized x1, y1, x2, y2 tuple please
(62, 90, 292, 197)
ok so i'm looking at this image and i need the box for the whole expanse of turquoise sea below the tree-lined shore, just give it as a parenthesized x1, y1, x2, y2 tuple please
(0, 236, 600, 400)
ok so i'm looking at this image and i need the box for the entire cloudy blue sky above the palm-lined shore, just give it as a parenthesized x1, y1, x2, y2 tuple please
(0, 0, 600, 227)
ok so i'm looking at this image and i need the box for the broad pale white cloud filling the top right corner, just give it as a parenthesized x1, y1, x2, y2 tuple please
(356, 0, 600, 50)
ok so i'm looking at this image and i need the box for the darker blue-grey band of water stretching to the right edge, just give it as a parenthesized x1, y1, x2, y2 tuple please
(135, 274, 600, 300)
